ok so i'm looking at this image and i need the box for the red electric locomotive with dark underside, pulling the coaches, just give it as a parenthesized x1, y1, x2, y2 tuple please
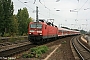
(28, 20, 58, 44)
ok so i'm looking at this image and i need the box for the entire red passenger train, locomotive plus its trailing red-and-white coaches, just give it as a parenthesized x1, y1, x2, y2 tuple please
(28, 20, 80, 44)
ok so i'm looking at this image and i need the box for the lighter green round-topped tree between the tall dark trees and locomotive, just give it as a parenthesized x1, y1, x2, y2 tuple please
(17, 8, 32, 35)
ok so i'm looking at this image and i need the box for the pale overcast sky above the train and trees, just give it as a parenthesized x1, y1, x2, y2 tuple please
(12, 0, 90, 31)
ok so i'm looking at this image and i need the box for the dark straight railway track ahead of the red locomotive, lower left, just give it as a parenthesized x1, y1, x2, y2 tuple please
(0, 42, 36, 58)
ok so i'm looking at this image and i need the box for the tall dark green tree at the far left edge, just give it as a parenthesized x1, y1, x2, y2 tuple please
(0, 0, 14, 36)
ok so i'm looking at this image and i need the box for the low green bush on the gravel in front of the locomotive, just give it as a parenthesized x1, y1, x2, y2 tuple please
(23, 45, 48, 58)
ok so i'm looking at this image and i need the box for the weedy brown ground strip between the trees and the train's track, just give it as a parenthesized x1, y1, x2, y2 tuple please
(0, 36, 28, 49)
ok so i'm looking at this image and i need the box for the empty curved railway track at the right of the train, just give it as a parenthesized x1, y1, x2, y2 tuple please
(71, 36, 90, 60)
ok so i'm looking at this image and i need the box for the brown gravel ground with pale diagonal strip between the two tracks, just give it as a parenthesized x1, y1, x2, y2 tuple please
(18, 37, 75, 60)
